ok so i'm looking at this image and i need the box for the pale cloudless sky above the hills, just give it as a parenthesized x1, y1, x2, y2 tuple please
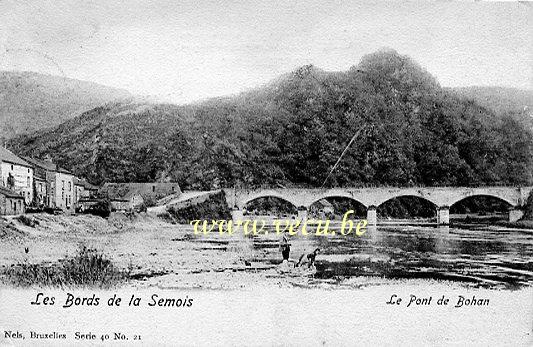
(0, 0, 533, 103)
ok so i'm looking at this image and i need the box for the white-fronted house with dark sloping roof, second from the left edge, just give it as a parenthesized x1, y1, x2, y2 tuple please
(24, 157, 75, 213)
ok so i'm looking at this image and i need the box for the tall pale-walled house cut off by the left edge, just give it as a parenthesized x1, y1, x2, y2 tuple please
(0, 147, 33, 205)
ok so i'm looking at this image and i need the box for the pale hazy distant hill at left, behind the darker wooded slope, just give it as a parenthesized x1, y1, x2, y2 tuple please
(0, 71, 132, 140)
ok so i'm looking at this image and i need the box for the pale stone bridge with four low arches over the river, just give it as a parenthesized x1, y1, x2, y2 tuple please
(224, 187, 533, 225)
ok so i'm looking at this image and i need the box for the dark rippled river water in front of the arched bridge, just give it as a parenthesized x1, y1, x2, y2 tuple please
(248, 226, 533, 288)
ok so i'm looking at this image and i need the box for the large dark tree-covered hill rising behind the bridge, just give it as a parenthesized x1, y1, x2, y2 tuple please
(8, 50, 533, 189)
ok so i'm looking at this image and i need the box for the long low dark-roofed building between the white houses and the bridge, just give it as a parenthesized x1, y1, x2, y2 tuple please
(99, 182, 181, 211)
